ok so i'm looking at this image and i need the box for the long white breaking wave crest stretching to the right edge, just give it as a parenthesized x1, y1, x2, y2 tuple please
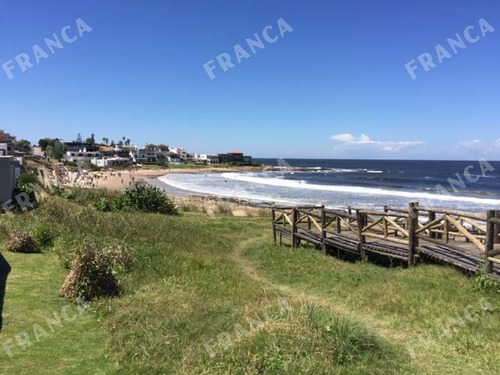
(222, 173, 500, 206)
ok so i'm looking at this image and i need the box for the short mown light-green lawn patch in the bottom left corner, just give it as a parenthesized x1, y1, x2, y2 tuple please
(0, 253, 113, 374)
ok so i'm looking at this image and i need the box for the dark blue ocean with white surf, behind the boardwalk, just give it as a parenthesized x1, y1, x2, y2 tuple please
(159, 159, 500, 212)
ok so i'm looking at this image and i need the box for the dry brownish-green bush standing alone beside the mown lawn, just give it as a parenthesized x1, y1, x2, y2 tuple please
(60, 239, 120, 302)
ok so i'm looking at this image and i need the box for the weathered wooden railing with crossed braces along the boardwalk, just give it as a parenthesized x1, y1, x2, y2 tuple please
(273, 203, 500, 273)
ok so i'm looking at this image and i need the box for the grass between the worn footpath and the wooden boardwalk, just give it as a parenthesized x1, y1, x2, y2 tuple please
(245, 245, 500, 374)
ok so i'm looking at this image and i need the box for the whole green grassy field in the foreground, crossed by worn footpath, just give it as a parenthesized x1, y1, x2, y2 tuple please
(0, 198, 500, 374)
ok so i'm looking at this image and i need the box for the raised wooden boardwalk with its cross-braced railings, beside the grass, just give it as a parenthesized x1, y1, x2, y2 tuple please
(272, 203, 500, 279)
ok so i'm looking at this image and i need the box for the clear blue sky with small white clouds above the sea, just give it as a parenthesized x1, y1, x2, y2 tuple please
(0, 0, 500, 160)
